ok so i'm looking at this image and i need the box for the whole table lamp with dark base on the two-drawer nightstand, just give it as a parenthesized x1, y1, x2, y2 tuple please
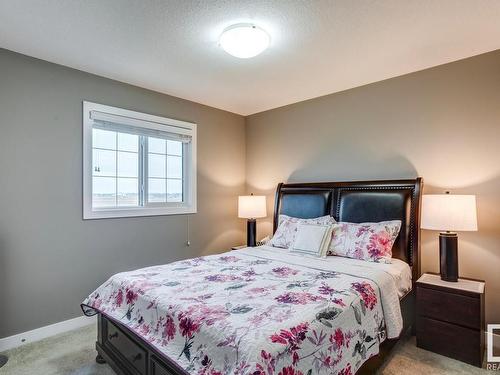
(422, 192, 477, 282)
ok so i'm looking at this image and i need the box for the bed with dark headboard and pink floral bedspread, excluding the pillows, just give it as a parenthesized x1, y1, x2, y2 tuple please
(82, 178, 422, 375)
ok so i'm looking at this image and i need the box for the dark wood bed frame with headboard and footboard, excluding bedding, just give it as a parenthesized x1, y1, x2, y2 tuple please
(96, 178, 422, 375)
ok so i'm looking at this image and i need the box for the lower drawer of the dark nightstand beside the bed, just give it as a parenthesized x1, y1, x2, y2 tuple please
(417, 316, 483, 367)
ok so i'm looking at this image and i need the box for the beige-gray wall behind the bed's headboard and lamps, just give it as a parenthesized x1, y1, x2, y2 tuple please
(246, 51, 500, 323)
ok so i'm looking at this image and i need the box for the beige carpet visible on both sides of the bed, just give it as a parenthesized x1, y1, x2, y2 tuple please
(0, 325, 492, 375)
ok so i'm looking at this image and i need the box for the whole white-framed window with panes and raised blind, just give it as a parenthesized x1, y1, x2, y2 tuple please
(83, 102, 196, 219)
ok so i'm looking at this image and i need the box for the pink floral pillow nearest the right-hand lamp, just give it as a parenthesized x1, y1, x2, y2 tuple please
(328, 220, 401, 263)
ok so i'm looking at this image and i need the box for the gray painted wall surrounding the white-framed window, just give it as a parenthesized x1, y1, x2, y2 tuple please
(0, 49, 245, 338)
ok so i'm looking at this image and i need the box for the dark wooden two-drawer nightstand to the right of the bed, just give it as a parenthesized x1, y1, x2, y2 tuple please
(417, 273, 484, 367)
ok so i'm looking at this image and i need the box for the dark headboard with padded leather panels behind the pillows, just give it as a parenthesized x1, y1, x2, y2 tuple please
(273, 177, 422, 282)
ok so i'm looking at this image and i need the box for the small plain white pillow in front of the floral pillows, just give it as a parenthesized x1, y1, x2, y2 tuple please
(290, 224, 332, 257)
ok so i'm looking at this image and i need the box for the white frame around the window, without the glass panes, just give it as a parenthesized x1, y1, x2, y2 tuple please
(83, 101, 197, 220)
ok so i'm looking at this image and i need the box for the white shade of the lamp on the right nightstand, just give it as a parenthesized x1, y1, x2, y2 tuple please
(422, 194, 477, 232)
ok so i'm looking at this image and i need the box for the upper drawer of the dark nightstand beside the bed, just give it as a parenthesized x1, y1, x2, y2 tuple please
(417, 285, 481, 330)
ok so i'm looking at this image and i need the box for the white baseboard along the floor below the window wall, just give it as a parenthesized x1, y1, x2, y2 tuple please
(0, 316, 97, 352)
